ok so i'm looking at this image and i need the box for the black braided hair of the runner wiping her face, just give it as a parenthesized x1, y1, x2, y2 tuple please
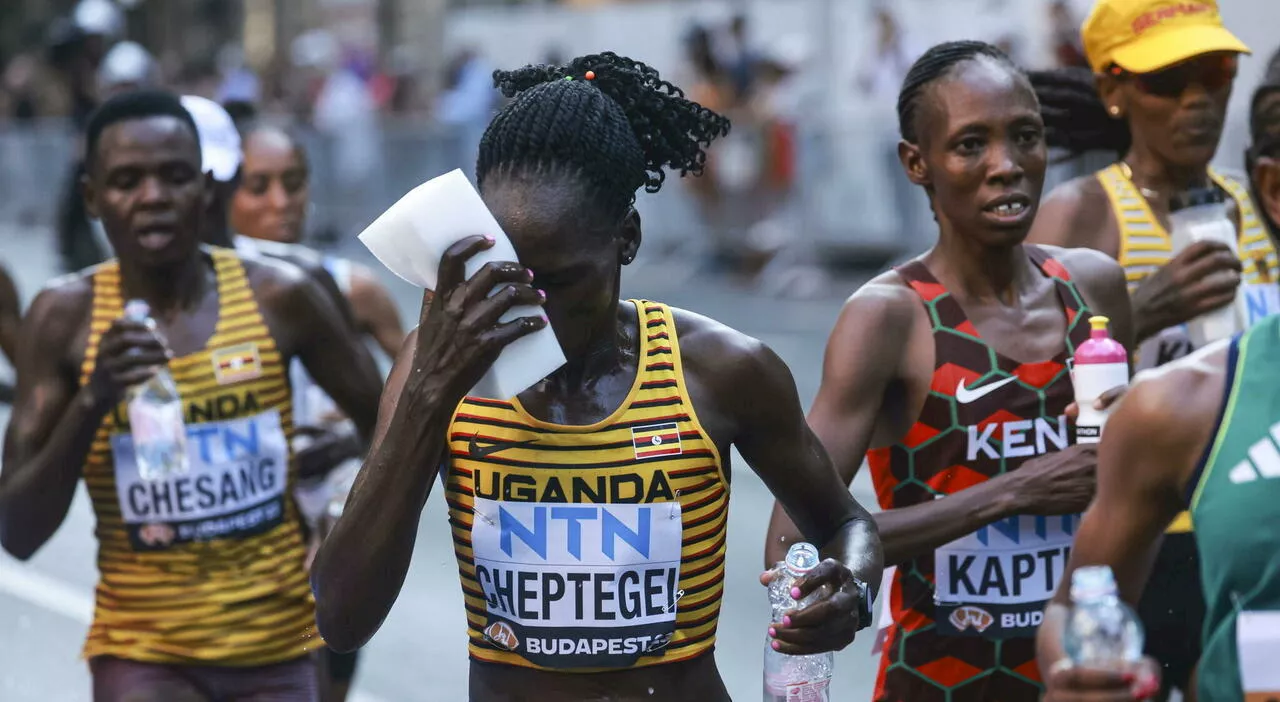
(476, 53, 730, 218)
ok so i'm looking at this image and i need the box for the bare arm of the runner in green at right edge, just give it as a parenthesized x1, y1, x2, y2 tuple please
(1037, 345, 1226, 676)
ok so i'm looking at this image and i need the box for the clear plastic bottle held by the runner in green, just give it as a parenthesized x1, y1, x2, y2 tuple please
(1062, 565, 1144, 670)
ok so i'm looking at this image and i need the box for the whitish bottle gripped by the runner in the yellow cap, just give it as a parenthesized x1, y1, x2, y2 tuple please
(1169, 187, 1248, 348)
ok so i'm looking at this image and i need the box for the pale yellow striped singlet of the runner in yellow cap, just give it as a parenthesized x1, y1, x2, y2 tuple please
(1097, 161, 1280, 533)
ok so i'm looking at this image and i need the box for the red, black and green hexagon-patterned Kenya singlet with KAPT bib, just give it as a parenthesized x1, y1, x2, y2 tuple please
(867, 246, 1089, 702)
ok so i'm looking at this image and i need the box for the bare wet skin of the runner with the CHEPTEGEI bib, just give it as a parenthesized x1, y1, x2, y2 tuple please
(312, 177, 882, 702)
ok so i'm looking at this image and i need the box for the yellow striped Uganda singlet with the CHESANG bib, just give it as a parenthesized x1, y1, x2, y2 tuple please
(81, 249, 321, 666)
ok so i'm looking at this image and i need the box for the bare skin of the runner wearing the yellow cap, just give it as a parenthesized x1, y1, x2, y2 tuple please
(1028, 54, 1240, 348)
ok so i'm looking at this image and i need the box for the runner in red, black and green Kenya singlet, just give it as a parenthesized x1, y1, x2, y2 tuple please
(765, 41, 1130, 702)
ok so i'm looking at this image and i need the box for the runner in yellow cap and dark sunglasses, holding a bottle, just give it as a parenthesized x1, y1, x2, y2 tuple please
(1030, 0, 1280, 697)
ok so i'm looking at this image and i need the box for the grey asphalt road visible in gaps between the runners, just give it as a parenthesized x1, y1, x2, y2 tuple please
(0, 225, 876, 702)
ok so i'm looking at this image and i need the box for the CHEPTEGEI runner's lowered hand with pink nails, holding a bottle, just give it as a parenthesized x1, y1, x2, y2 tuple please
(760, 559, 861, 656)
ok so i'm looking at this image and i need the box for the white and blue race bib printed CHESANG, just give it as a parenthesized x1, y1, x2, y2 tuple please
(111, 410, 289, 551)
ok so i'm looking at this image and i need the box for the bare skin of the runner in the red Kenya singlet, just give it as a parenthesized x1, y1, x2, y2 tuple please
(764, 59, 1132, 566)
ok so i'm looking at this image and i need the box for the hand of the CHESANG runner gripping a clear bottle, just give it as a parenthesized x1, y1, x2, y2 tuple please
(90, 319, 173, 406)
